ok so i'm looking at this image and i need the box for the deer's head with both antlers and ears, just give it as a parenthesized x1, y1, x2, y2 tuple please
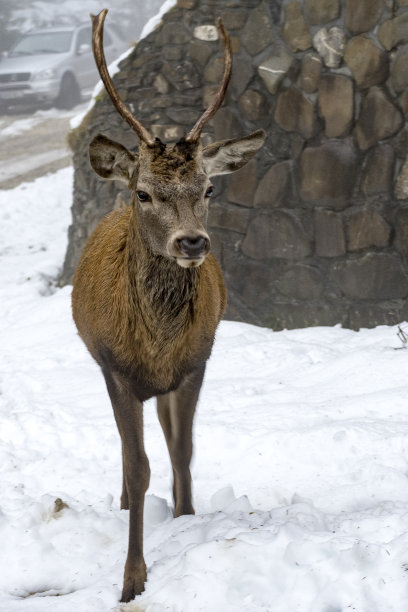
(89, 9, 265, 268)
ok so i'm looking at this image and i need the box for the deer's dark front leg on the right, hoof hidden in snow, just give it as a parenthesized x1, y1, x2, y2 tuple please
(157, 363, 205, 516)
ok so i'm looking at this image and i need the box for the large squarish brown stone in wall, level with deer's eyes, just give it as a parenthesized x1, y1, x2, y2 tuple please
(299, 141, 358, 208)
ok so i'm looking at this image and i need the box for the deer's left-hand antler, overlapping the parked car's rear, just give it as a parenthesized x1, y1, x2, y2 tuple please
(91, 9, 154, 146)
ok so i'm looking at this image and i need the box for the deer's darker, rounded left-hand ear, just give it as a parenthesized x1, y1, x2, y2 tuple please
(89, 134, 137, 184)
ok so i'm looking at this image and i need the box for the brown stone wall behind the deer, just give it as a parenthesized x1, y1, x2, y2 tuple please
(62, 0, 408, 329)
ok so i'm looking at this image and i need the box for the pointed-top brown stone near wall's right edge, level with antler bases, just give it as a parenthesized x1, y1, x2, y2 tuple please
(355, 87, 403, 151)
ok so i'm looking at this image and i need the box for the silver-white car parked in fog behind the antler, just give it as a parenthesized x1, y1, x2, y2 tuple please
(0, 24, 126, 110)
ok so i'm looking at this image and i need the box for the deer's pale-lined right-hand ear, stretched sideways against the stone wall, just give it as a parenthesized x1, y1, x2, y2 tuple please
(203, 130, 266, 176)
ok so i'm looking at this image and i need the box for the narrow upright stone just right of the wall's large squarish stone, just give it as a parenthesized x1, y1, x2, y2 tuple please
(361, 144, 395, 197)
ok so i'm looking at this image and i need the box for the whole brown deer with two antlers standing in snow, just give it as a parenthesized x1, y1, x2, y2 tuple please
(72, 9, 265, 602)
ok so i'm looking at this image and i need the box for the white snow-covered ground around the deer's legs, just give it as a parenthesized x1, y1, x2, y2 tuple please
(0, 169, 408, 612)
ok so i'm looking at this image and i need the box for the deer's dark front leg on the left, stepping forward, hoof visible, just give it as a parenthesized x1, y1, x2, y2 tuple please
(105, 374, 150, 602)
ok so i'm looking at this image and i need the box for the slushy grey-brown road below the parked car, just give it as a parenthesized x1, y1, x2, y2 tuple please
(0, 104, 87, 189)
